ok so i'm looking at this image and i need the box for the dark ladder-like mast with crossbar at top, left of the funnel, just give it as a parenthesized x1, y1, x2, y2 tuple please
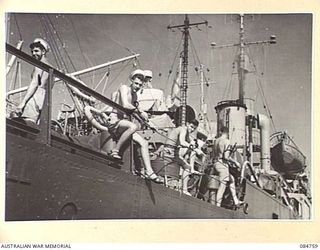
(167, 15, 208, 125)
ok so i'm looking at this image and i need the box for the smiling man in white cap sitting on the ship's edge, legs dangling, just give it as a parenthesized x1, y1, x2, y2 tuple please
(102, 69, 163, 183)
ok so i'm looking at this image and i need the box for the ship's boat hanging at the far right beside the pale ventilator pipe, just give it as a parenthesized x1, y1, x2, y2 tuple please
(270, 132, 306, 174)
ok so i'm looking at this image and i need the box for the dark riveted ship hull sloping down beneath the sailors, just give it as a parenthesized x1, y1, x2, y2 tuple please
(5, 118, 294, 221)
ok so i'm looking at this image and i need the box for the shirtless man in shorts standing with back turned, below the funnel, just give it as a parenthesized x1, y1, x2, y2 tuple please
(213, 127, 242, 207)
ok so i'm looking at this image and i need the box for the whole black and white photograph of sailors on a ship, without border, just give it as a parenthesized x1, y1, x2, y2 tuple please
(5, 12, 313, 221)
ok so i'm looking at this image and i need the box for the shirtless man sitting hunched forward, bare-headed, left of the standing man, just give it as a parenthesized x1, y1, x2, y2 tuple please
(163, 119, 203, 196)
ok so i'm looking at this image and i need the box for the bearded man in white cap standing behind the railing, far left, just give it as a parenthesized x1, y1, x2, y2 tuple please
(15, 38, 50, 124)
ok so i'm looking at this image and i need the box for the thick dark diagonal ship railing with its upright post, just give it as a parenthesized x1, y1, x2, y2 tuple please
(6, 43, 132, 159)
